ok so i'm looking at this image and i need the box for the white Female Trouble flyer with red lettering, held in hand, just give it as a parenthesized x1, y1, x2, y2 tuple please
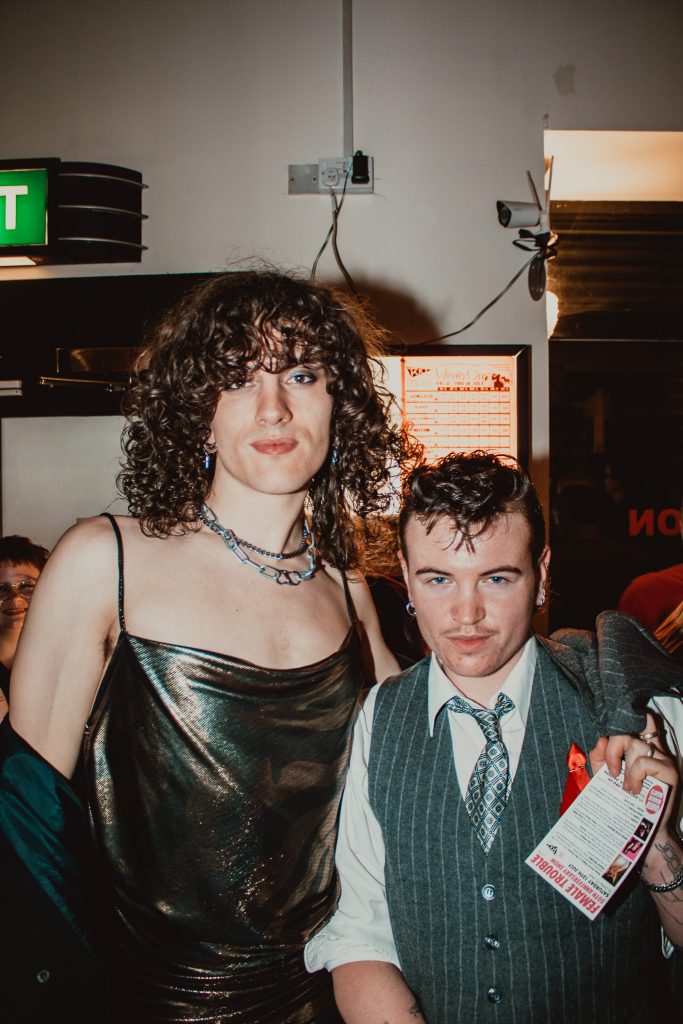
(525, 766, 669, 921)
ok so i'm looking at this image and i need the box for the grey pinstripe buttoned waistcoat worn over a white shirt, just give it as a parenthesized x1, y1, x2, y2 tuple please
(369, 645, 663, 1024)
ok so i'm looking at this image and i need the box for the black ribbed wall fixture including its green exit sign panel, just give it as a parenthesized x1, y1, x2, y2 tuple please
(0, 158, 146, 267)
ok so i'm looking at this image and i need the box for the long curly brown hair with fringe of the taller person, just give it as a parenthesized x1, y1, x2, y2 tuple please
(118, 269, 421, 569)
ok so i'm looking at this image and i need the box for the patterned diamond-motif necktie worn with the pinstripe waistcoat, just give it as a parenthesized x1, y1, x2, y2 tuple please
(446, 693, 515, 853)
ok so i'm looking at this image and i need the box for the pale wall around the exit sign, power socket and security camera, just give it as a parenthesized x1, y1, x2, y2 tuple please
(0, 0, 683, 520)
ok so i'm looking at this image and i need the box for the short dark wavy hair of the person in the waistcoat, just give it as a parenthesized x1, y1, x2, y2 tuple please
(398, 451, 546, 565)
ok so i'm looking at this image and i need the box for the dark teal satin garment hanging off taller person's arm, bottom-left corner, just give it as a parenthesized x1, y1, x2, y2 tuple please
(0, 717, 114, 1024)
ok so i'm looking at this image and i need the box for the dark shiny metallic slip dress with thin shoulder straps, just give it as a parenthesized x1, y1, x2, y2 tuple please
(84, 517, 362, 1024)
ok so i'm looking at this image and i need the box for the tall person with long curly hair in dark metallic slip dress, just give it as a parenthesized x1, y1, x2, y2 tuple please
(11, 270, 418, 1024)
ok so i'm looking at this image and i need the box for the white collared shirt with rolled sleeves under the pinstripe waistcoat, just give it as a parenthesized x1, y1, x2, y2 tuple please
(304, 637, 683, 972)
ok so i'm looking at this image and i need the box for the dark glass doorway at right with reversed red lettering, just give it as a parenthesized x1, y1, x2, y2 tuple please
(549, 197, 683, 630)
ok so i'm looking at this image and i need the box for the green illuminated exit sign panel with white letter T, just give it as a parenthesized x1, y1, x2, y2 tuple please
(0, 167, 47, 246)
